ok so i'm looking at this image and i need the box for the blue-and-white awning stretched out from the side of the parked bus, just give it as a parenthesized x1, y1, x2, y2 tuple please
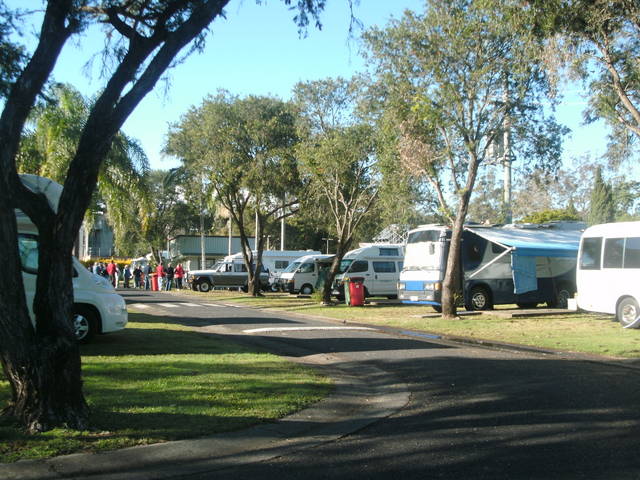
(466, 227, 582, 257)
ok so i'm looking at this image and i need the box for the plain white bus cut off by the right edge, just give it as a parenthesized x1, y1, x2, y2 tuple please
(576, 222, 640, 328)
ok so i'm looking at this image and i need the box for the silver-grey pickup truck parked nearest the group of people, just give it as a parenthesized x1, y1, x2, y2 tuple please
(187, 262, 269, 292)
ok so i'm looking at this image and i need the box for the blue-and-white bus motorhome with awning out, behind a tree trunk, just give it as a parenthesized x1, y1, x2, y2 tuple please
(398, 222, 583, 311)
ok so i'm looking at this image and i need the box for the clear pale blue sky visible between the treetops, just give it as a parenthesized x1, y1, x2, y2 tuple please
(13, 0, 606, 169)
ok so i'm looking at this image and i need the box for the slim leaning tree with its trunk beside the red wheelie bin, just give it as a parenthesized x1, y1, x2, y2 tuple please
(294, 78, 380, 304)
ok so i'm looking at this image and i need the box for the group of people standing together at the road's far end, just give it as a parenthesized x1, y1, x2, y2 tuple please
(90, 260, 185, 290)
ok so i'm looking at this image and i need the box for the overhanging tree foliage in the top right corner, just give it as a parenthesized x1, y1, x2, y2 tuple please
(530, 0, 640, 157)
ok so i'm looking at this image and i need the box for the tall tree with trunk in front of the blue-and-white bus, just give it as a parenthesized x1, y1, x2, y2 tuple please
(365, 0, 560, 318)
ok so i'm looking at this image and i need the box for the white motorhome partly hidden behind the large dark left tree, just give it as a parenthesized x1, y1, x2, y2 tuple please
(16, 174, 128, 342)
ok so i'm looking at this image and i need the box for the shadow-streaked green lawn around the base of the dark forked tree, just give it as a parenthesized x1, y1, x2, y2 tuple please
(0, 313, 332, 462)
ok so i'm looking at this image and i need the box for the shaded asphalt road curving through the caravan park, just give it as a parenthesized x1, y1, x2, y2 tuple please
(121, 292, 640, 480)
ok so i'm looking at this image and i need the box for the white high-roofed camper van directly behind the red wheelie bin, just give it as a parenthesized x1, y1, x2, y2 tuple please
(333, 243, 404, 298)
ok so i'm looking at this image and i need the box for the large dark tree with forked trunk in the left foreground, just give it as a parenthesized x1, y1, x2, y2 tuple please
(0, 0, 324, 432)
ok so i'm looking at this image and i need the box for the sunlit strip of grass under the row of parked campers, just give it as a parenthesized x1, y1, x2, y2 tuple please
(175, 291, 640, 358)
